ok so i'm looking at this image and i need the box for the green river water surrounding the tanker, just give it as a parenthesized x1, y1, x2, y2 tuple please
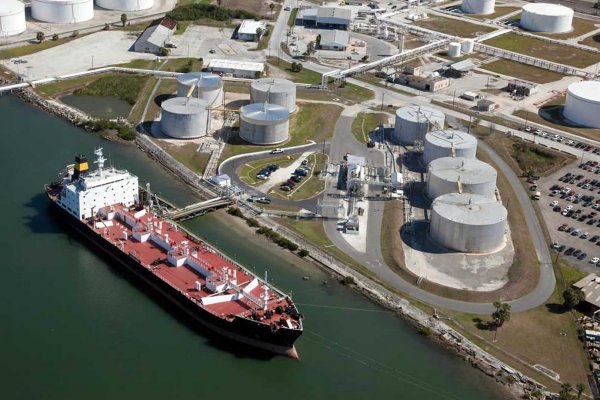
(0, 97, 504, 400)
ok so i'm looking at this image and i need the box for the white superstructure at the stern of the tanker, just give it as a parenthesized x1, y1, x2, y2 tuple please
(57, 148, 139, 220)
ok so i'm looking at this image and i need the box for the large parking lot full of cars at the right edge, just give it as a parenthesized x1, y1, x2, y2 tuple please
(529, 159, 600, 272)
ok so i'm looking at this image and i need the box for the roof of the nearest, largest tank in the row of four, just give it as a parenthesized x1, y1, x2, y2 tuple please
(431, 193, 508, 225)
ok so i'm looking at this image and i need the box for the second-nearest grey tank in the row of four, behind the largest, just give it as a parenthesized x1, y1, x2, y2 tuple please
(427, 157, 498, 199)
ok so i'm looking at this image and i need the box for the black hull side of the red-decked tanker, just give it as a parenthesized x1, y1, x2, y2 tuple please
(50, 198, 302, 359)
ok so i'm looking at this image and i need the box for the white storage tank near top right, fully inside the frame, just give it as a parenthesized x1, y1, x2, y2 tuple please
(521, 3, 573, 33)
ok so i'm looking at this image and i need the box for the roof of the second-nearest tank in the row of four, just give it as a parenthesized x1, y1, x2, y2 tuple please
(429, 157, 498, 184)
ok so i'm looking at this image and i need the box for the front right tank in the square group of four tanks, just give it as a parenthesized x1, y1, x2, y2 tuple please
(240, 103, 290, 145)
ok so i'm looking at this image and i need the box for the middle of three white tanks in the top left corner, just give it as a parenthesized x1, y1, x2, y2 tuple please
(31, 0, 94, 24)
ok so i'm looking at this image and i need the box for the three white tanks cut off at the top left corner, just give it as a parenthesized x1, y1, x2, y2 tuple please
(0, 0, 154, 36)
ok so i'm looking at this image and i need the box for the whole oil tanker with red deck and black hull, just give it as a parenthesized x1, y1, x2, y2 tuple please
(45, 149, 303, 358)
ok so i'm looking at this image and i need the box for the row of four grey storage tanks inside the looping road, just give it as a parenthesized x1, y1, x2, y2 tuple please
(392, 106, 508, 253)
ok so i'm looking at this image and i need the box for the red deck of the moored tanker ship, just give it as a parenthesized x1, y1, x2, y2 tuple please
(88, 205, 298, 327)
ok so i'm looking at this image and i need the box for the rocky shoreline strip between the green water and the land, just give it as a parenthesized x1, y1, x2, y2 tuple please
(14, 88, 546, 399)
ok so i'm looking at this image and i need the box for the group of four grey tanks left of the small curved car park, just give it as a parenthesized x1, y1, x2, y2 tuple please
(161, 72, 296, 145)
